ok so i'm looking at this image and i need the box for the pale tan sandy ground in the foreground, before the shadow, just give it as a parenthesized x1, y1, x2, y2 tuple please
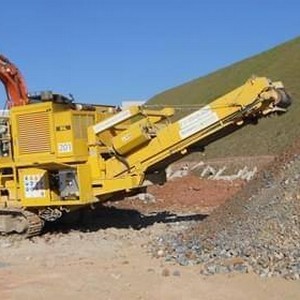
(0, 222, 300, 300)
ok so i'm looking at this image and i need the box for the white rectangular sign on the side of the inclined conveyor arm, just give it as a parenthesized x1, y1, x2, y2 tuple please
(179, 105, 219, 139)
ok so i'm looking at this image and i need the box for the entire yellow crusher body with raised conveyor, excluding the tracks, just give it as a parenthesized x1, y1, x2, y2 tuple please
(0, 77, 288, 209)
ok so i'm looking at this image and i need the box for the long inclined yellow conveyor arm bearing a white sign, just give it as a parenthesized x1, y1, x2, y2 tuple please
(106, 78, 278, 178)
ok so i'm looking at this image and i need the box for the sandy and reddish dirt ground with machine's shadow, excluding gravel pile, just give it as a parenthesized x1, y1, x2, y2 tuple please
(0, 162, 300, 300)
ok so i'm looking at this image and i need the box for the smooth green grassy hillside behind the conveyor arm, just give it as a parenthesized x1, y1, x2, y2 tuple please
(148, 37, 300, 158)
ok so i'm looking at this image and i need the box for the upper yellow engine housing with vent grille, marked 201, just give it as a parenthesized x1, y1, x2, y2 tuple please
(11, 102, 96, 164)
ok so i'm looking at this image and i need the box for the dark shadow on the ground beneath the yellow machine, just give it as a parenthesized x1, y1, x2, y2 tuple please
(44, 206, 207, 233)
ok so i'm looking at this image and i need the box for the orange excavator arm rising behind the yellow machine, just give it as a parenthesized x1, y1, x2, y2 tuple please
(0, 54, 29, 108)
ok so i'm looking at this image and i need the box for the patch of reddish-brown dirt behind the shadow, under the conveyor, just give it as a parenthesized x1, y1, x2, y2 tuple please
(114, 175, 245, 214)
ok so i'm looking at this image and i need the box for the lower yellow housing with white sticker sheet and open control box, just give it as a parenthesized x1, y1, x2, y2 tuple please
(19, 165, 92, 207)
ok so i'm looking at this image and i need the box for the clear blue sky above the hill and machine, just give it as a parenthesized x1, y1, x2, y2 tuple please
(0, 0, 300, 105)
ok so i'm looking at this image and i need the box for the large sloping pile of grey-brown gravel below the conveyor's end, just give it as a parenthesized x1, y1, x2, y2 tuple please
(152, 144, 300, 279)
